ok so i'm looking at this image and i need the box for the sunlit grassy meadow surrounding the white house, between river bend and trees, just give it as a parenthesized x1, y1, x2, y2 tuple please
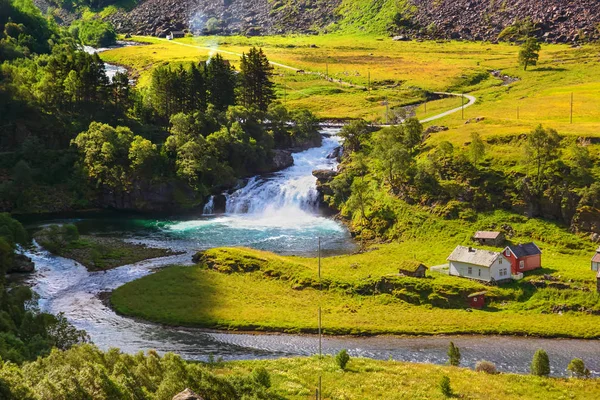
(112, 210, 600, 337)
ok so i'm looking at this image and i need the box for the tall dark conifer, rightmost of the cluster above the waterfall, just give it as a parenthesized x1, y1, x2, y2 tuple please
(239, 47, 275, 112)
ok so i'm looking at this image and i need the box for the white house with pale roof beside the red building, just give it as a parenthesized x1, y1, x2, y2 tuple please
(448, 246, 512, 282)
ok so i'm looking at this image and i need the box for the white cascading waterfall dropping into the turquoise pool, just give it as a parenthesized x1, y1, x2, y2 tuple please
(221, 131, 340, 216)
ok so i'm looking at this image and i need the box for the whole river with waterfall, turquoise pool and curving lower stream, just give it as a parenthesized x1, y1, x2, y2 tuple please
(22, 130, 600, 376)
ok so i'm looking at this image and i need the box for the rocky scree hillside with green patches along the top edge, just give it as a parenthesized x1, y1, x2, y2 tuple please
(104, 0, 600, 43)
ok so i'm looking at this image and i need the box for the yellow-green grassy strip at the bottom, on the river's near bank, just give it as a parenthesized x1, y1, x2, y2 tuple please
(215, 357, 600, 400)
